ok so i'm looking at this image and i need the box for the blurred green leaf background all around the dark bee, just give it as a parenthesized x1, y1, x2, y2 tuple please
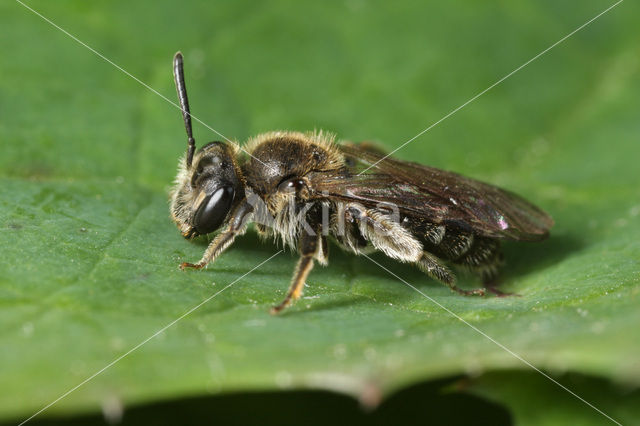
(0, 0, 640, 425)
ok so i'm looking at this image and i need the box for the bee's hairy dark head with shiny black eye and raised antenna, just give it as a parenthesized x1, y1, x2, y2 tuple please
(171, 52, 244, 238)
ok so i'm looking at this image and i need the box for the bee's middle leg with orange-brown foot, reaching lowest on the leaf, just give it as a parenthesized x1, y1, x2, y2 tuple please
(270, 213, 326, 315)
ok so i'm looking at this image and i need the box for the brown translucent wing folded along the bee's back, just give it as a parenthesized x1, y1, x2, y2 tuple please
(313, 144, 553, 241)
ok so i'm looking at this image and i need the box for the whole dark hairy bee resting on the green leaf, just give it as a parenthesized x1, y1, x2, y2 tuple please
(170, 52, 553, 314)
